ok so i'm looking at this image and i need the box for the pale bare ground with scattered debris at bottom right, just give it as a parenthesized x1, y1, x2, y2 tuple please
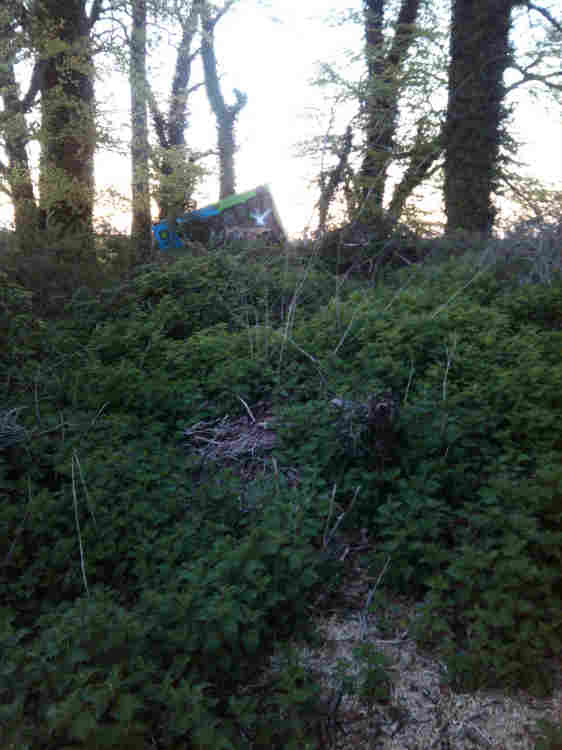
(272, 538, 562, 750)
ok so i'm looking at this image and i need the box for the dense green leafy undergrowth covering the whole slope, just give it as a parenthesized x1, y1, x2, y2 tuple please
(0, 234, 562, 750)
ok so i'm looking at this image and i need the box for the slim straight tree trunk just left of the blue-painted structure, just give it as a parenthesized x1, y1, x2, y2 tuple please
(129, 0, 152, 259)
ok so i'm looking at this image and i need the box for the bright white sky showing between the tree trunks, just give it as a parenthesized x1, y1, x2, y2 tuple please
(0, 0, 562, 235)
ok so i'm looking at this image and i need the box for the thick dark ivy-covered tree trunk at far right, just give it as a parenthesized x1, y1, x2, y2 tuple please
(444, 0, 516, 235)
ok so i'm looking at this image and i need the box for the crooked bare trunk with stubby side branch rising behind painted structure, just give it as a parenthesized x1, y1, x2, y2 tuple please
(201, 3, 248, 199)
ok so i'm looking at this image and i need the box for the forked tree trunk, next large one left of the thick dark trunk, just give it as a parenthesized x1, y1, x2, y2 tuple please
(361, 0, 420, 220)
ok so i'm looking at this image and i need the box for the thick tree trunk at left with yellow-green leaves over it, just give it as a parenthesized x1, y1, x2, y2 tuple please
(36, 0, 95, 234)
